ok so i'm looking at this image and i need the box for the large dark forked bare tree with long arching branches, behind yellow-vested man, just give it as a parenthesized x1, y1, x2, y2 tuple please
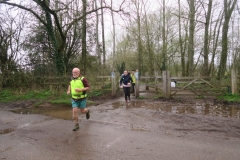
(0, 0, 124, 75)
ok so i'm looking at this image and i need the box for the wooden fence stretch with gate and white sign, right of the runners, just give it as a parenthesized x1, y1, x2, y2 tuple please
(138, 71, 233, 97)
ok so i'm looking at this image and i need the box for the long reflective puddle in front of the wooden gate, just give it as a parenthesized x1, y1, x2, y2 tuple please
(112, 101, 240, 118)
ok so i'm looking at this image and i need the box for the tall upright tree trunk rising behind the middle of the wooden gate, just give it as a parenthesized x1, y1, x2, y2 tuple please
(203, 0, 212, 76)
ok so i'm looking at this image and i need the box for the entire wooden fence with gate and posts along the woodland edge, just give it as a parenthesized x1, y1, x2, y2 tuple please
(39, 70, 240, 97)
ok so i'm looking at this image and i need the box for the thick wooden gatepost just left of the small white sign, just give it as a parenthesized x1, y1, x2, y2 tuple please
(162, 71, 171, 97)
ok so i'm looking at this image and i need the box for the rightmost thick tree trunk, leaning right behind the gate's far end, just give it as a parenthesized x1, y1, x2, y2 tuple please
(218, 0, 237, 79)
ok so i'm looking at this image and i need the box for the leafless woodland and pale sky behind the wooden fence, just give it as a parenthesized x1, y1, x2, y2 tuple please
(0, 0, 240, 89)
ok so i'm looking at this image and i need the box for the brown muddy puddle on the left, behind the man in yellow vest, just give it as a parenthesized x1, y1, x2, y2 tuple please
(12, 107, 72, 120)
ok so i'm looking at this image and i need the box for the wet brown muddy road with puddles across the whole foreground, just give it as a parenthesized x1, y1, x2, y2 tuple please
(0, 93, 240, 160)
